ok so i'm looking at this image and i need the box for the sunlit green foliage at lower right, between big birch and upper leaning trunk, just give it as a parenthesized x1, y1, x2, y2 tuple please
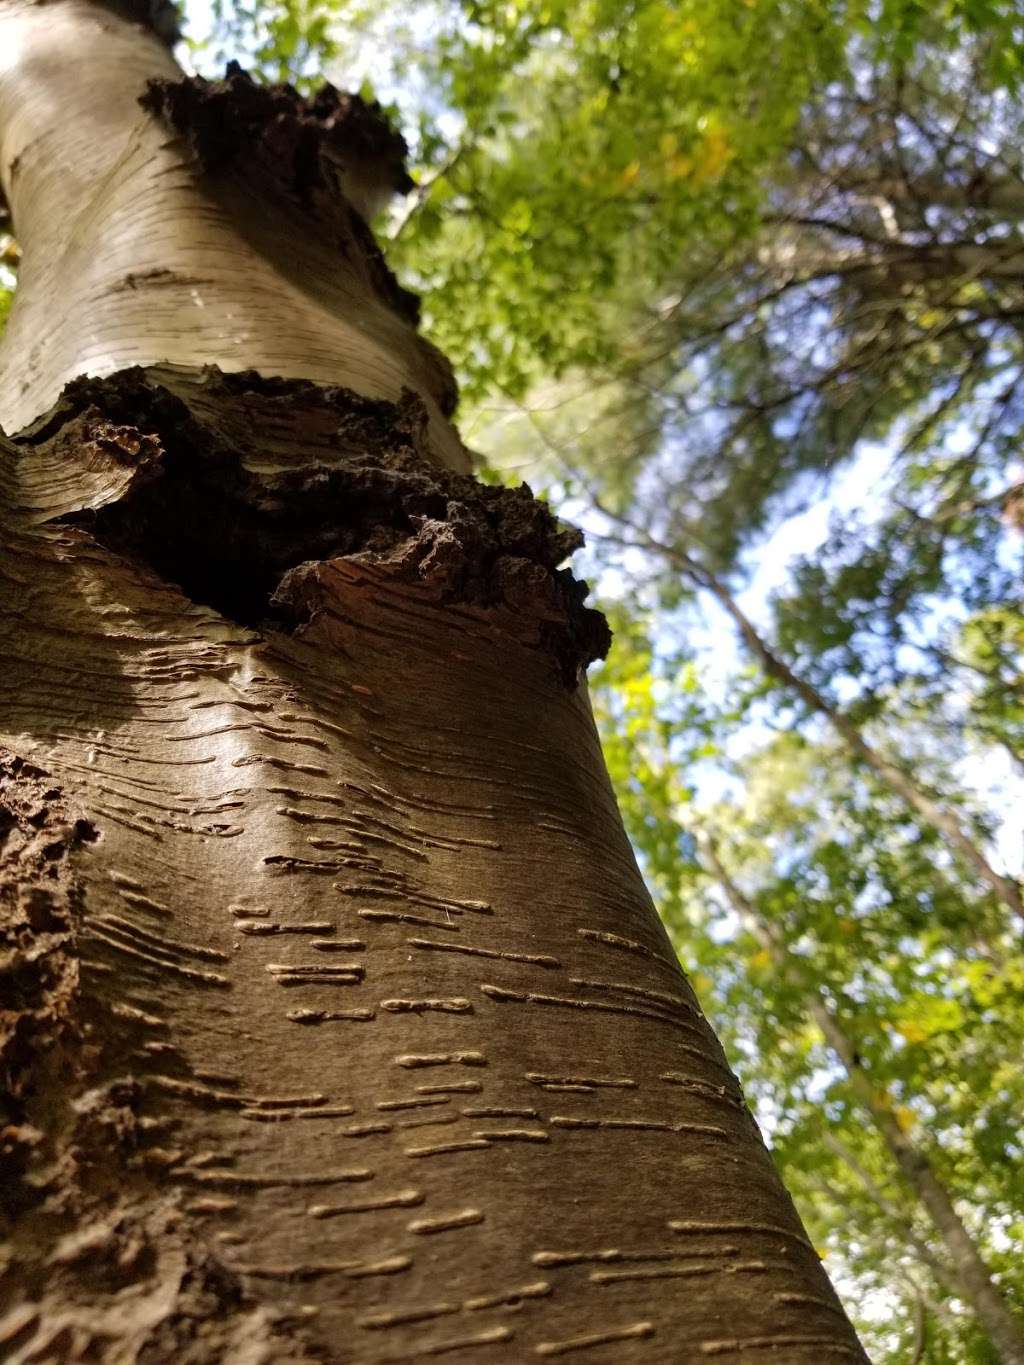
(595, 636, 1024, 1365)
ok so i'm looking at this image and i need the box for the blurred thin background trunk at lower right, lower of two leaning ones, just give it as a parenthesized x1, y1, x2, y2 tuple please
(700, 837, 1024, 1365)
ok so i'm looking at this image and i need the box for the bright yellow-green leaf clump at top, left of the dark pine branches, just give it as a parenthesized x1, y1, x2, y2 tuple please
(408, 0, 837, 394)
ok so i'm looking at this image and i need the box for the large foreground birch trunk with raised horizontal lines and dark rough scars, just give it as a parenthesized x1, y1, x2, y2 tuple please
(0, 0, 864, 1365)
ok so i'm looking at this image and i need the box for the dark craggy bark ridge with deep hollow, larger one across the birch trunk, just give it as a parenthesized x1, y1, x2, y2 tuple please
(19, 370, 610, 685)
